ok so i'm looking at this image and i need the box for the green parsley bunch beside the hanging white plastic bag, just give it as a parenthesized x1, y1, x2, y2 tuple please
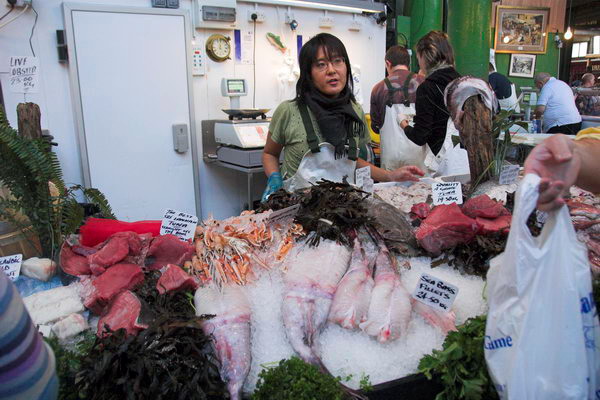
(419, 315, 498, 400)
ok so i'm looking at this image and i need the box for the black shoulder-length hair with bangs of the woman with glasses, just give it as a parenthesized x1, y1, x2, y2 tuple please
(296, 32, 356, 101)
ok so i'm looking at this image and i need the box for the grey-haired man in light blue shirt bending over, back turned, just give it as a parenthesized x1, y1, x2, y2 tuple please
(534, 72, 581, 135)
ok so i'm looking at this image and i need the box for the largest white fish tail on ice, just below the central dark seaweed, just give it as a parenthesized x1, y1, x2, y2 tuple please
(281, 240, 350, 366)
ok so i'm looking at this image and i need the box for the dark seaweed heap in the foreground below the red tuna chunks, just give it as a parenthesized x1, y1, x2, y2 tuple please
(76, 271, 227, 400)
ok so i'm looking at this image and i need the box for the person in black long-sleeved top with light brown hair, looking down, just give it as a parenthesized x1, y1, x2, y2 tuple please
(400, 31, 460, 155)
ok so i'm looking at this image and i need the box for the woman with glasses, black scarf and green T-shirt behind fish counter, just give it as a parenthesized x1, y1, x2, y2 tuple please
(262, 33, 423, 201)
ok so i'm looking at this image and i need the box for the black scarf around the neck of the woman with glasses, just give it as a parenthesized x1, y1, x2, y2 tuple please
(302, 87, 365, 160)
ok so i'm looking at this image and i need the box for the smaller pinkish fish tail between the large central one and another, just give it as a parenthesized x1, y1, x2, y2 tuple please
(329, 239, 375, 329)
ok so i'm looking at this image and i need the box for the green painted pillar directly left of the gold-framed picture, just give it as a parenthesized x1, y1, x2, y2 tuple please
(448, 0, 492, 79)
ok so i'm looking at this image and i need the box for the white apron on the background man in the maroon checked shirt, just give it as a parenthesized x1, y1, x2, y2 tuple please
(379, 104, 431, 170)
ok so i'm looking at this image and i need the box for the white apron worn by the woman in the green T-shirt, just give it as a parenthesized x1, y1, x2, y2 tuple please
(283, 143, 356, 192)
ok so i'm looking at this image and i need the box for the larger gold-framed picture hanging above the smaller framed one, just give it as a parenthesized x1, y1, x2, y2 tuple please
(494, 6, 550, 54)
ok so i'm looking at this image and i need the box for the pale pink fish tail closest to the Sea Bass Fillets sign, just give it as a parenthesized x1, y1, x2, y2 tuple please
(359, 243, 412, 343)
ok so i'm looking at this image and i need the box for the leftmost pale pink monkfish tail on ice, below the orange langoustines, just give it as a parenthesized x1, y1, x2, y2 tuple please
(194, 286, 252, 400)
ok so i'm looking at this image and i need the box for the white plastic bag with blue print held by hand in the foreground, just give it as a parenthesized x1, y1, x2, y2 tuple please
(484, 174, 600, 400)
